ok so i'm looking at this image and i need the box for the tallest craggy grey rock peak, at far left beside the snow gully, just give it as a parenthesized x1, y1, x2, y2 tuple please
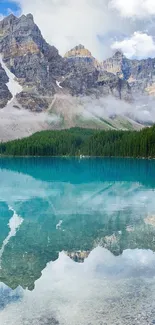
(0, 14, 63, 111)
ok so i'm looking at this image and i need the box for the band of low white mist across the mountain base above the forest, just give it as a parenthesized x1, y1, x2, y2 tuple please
(0, 94, 155, 141)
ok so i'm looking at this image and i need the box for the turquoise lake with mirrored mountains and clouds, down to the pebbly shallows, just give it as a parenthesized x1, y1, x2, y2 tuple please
(0, 158, 155, 325)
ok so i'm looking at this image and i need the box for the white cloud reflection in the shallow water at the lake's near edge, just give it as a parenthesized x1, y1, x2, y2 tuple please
(1, 247, 155, 325)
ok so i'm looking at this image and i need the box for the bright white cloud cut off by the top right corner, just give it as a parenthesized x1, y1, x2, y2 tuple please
(111, 0, 155, 18)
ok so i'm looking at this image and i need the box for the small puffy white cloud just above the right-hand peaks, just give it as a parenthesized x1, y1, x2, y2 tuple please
(112, 32, 155, 59)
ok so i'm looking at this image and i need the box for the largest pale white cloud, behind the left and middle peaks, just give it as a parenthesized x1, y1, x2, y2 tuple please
(12, 0, 118, 57)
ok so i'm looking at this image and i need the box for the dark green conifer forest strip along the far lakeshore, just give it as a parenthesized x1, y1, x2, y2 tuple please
(0, 126, 155, 158)
